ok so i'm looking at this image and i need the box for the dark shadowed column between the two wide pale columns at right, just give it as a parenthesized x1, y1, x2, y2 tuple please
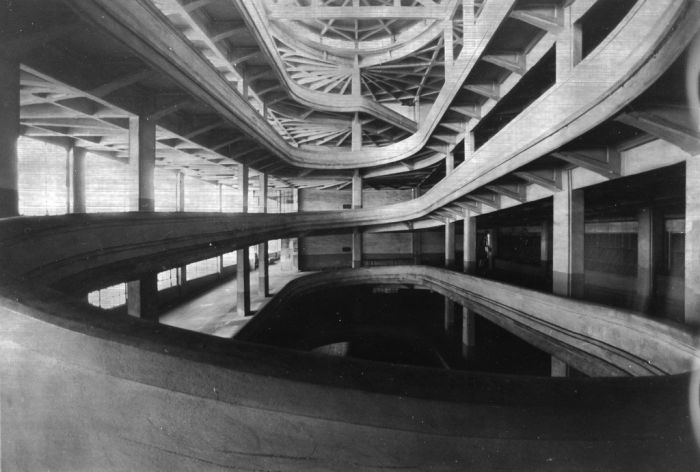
(635, 208, 664, 313)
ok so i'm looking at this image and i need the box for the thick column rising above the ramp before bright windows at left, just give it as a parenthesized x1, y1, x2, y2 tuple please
(129, 116, 156, 211)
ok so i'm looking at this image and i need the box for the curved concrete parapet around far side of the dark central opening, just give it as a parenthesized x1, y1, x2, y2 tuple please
(236, 266, 700, 376)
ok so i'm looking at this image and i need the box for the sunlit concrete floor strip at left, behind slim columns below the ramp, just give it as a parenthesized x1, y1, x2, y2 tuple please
(160, 262, 306, 338)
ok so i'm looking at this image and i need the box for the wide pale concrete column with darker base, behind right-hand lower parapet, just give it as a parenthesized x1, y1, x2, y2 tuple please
(552, 170, 584, 298)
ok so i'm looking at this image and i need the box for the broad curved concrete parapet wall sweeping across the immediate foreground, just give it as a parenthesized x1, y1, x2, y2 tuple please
(0, 272, 699, 471)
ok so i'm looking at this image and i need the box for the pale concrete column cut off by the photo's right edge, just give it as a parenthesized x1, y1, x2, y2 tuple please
(685, 156, 700, 326)
